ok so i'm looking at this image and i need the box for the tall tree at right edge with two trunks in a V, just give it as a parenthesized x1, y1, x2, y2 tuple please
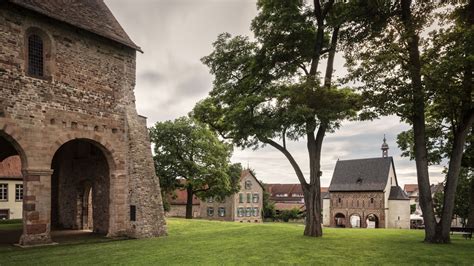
(346, 0, 474, 243)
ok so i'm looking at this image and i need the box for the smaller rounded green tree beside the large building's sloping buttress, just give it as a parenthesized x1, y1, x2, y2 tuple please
(150, 117, 242, 219)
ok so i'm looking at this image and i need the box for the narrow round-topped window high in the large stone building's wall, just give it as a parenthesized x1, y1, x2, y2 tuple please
(28, 34, 44, 77)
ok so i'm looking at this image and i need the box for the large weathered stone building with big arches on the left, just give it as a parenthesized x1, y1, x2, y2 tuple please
(0, 0, 166, 245)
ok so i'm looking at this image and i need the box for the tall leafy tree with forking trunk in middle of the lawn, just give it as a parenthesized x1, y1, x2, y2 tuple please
(194, 0, 360, 236)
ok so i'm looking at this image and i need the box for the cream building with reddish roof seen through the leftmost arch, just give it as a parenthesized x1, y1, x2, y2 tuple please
(0, 156, 23, 220)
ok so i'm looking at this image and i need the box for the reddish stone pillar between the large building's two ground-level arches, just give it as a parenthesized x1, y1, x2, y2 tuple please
(20, 169, 53, 246)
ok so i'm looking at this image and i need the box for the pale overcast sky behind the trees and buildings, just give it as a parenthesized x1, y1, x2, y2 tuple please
(106, 0, 443, 186)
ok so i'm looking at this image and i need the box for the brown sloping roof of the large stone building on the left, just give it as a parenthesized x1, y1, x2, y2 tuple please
(8, 0, 141, 52)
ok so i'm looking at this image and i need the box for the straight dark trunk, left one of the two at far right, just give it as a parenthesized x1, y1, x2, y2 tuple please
(401, 0, 439, 242)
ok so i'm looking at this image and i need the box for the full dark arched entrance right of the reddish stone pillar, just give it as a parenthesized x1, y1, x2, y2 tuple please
(51, 139, 110, 234)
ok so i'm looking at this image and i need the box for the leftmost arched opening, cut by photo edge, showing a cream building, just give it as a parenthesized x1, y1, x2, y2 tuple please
(0, 131, 25, 245)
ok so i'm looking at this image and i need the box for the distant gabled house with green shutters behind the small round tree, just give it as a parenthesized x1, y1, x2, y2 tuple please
(168, 170, 263, 223)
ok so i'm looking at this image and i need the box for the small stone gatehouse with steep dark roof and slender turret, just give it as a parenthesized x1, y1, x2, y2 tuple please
(323, 139, 410, 229)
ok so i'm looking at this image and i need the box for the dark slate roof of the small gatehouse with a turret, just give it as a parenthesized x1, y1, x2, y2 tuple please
(329, 157, 393, 192)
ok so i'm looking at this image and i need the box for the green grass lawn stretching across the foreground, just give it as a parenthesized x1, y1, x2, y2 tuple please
(0, 219, 474, 265)
